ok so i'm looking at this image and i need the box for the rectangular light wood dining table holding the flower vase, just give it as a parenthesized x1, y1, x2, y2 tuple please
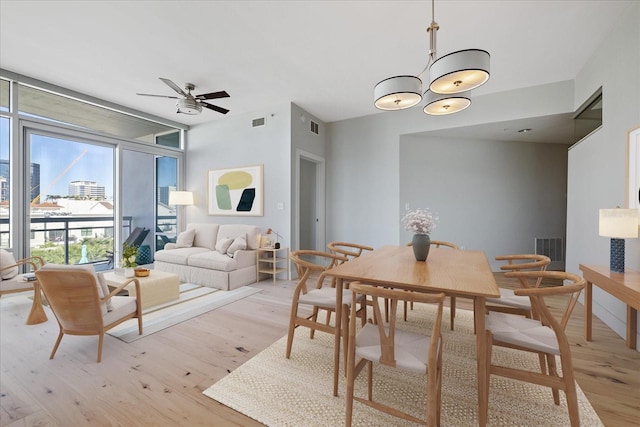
(325, 245, 500, 426)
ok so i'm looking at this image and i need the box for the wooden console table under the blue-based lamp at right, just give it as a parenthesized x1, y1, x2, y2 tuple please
(580, 264, 640, 349)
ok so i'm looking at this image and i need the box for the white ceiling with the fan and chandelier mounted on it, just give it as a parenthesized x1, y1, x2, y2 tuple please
(0, 0, 637, 139)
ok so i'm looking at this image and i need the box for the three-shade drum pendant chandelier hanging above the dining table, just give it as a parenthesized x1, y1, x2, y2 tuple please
(374, 0, 490, 115)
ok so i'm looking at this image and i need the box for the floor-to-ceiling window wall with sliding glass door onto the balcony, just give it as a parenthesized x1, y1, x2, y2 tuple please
(0, 69, 188, 265)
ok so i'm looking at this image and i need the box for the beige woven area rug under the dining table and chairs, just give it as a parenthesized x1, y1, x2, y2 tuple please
(203, 305, 602, 427)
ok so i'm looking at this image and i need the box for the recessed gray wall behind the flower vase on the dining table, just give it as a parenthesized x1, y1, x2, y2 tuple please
(398, 136, 567, 270)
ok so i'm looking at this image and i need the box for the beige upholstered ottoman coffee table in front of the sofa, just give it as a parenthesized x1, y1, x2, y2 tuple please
(104, 270, 180, 308)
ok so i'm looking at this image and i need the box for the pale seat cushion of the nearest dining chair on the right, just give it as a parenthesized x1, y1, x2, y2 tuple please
(485, 312, 560, 355)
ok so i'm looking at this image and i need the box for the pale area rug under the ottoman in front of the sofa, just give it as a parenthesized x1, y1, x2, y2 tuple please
(107, 283, 262, 342)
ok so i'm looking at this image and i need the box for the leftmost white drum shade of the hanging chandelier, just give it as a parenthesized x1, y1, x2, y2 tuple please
(373, 76, 422, 111)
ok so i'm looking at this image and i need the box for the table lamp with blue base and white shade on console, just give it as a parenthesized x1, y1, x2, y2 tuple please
(598, 208, 638, 273)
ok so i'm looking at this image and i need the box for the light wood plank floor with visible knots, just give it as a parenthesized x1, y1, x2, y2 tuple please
(0, 274, 640, 427)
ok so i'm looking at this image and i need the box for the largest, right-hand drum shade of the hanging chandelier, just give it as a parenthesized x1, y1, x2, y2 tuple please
(429, 49, 490, 94)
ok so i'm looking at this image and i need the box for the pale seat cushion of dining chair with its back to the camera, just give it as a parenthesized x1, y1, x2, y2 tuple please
(356, 323, 431, 374)
